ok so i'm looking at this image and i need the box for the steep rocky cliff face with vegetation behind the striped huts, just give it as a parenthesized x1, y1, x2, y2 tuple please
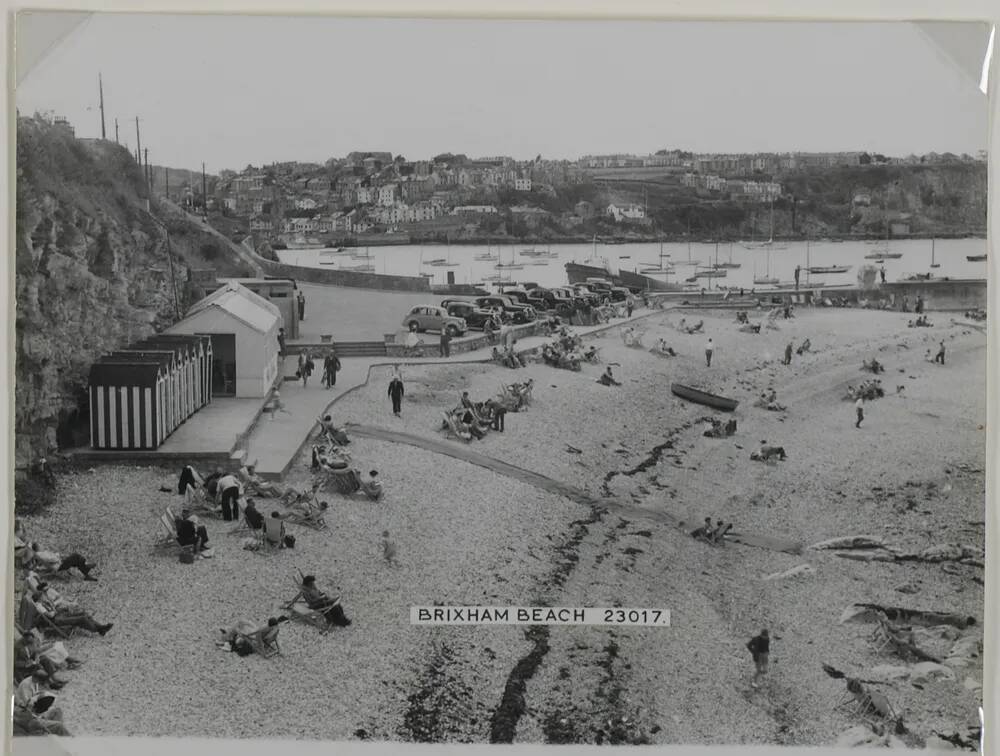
(15, 118, 252, 466)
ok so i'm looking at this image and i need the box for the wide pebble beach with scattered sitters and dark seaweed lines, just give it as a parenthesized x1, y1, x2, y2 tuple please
(24, 308, 986, 745)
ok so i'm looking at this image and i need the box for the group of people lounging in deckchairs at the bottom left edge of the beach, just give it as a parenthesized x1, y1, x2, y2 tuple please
(13, 518, 114, 735)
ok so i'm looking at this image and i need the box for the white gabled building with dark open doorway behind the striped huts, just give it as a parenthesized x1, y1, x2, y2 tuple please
(167, 282, 283, 398)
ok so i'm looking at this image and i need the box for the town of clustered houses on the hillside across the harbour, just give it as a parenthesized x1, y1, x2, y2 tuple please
(145, 145, 986, 248)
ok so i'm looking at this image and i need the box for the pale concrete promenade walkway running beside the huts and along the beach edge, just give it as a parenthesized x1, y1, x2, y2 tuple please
(246, 309, 662, 480)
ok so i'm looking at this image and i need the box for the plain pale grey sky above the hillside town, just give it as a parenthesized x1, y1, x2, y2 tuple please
(16, 14, 988, 172)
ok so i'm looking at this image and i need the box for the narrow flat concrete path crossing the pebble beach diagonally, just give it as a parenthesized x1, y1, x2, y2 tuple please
(350, 425, 802, 554)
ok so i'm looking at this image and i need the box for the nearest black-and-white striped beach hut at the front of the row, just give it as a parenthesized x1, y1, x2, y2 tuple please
(89, 360, 167, 450)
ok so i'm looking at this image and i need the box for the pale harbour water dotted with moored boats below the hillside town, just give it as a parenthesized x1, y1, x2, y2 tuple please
(277, 239, 987, 289)
